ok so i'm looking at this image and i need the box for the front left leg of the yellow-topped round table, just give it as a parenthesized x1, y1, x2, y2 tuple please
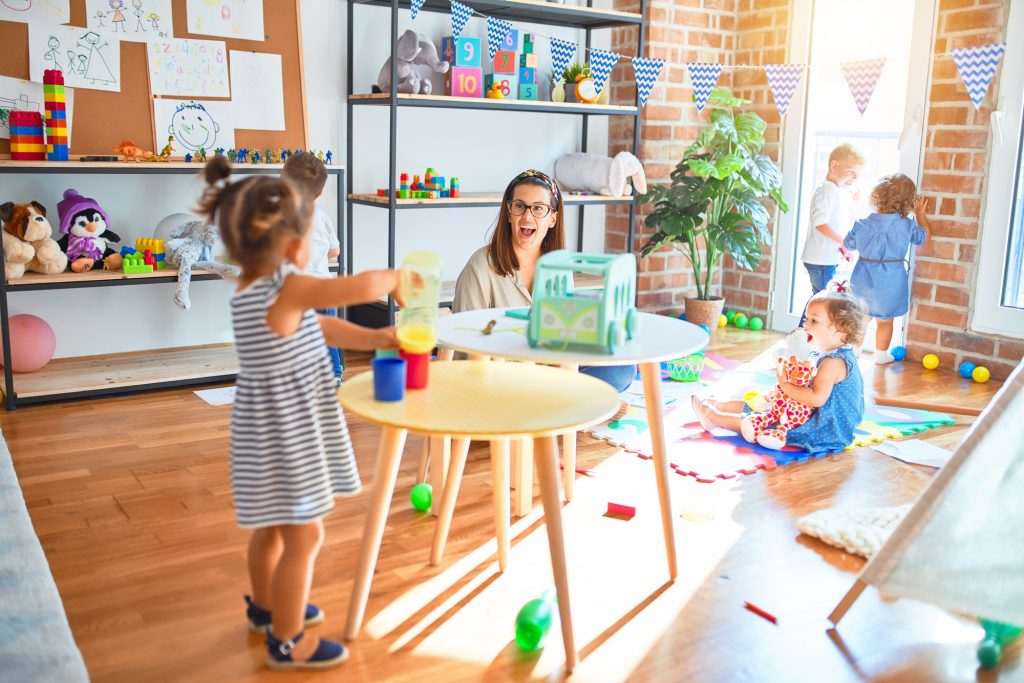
(345, 427, 407, 640)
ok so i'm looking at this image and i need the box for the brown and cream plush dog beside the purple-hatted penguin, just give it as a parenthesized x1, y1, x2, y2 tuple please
(0, 202, 68, 278)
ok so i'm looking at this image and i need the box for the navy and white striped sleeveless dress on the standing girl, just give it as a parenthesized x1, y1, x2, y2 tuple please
(231, 264, 360, 527)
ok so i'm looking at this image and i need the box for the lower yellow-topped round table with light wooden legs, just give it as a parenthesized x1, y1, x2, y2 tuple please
(338, 361, 618, 670)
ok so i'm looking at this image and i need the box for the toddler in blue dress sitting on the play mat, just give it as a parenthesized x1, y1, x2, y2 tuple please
(693, 283, 867, 453)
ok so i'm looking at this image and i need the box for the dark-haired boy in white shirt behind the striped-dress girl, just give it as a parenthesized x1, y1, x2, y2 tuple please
(281, 153, 344, 384)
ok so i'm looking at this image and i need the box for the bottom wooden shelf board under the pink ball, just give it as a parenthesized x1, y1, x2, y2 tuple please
(14, 344, 239, 405)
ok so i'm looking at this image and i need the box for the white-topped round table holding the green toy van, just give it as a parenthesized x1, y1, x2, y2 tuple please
(435, 308, 709, 580)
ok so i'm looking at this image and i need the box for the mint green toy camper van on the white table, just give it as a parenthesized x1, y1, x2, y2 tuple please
(526, 250, 637, 353)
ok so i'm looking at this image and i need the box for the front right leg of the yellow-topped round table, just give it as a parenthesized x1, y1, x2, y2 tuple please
(534, 436, 577, 672)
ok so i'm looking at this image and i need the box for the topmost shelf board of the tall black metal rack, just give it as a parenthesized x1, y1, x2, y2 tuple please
(353, 0, 643, 29)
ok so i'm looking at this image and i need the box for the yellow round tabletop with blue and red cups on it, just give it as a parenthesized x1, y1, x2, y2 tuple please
(338, 360, 618, 439)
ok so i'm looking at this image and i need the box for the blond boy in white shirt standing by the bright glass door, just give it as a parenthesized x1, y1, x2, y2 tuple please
(800, 142, 864, 326)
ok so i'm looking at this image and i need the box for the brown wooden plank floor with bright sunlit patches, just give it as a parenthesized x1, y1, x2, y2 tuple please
(0, 330, 1024, 683)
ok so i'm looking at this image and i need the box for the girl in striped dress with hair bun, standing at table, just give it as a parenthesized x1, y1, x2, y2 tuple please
(199, 157, 398, 669)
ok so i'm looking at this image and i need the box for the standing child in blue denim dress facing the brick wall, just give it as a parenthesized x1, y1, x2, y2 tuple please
(843, 173, 931, 366)
